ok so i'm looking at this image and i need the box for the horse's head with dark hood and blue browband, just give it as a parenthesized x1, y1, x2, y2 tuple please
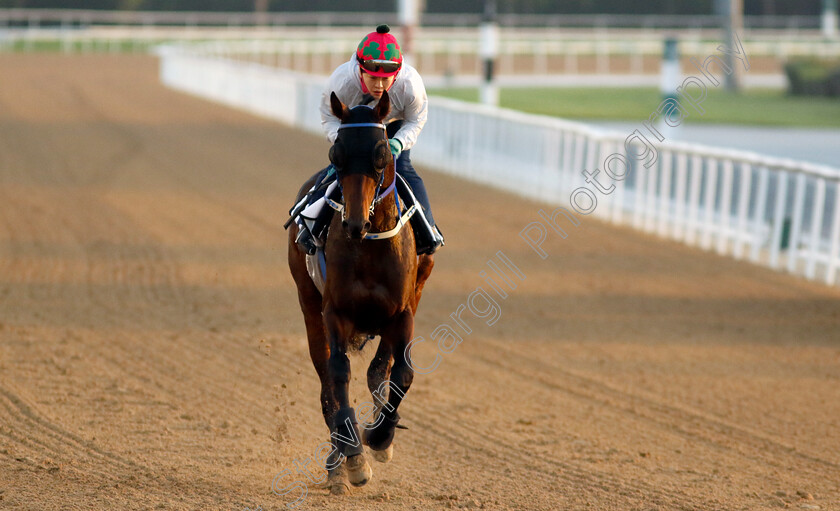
(330, 92, 393, 239)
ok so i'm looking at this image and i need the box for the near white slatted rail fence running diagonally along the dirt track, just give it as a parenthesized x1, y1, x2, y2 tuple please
(160, 47, 840, 285)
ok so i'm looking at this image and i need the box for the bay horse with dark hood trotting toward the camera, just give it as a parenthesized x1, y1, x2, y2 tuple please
(288, 92, 434, 494)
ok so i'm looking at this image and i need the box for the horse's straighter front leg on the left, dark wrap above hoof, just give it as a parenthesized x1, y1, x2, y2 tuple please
(324, 306, 373, 486)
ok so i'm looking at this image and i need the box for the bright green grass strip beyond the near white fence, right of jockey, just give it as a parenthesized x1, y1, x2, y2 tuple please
(429, 88, 840, 128)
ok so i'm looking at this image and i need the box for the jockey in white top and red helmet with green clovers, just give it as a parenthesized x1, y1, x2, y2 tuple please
(298, 25, 443, 254)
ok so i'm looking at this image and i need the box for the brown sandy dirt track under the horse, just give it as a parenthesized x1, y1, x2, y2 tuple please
(0, 55, 840, 510)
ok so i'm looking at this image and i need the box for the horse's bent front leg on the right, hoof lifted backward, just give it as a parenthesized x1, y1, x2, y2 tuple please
(365, 309, 414, 451)
